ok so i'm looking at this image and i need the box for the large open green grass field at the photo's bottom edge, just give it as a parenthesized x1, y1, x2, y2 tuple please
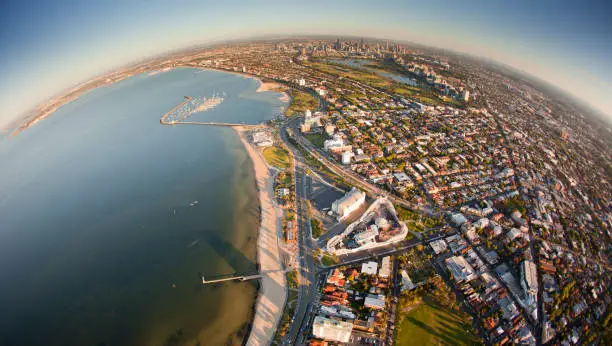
(395, 296, 480, 345)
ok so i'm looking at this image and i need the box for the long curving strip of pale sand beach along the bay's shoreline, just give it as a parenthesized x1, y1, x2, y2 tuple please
(234, 127, 287, 345)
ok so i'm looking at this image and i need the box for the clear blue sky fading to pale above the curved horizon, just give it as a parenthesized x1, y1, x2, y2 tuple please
(0, 0, 612, 129)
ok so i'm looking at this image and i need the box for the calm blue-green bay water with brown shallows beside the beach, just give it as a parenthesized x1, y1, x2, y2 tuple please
(0, 68, 285, 345)
